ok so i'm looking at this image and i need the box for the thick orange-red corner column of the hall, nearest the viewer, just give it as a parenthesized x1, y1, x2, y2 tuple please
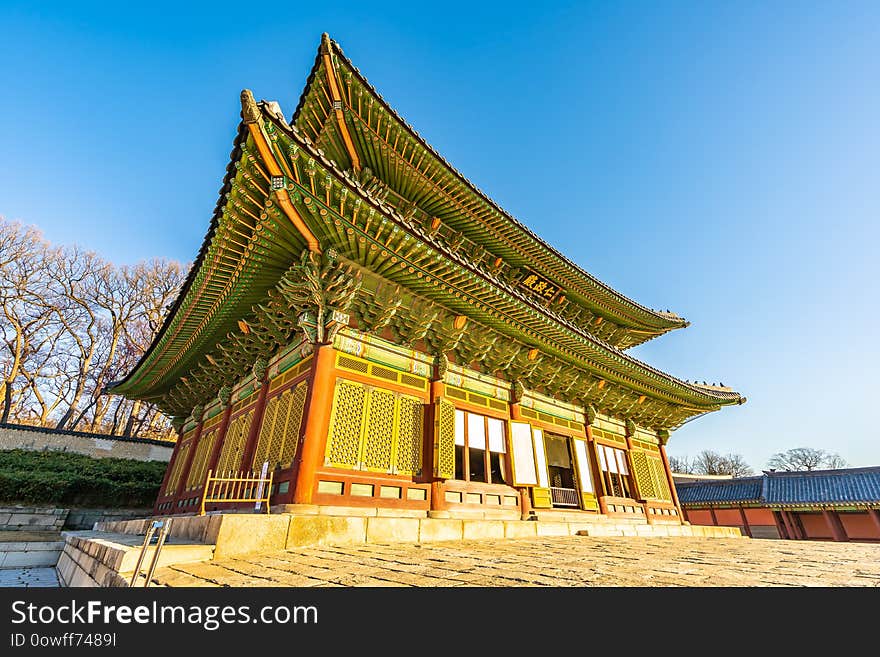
(293, 344, 336, 504)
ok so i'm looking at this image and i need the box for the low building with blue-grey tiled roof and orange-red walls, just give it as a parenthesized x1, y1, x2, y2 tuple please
(677, 467, 880, 541)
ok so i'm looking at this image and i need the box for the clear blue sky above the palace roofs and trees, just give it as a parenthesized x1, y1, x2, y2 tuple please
(0, 0, 880, 470)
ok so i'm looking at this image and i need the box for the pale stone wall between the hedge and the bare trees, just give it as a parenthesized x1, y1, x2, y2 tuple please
(0, 424, 174, 463)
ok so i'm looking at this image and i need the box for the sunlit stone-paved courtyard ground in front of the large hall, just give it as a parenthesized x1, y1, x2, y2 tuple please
(156, 536, 880, 587)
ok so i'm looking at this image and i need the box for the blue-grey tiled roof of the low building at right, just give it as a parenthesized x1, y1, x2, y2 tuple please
(676, 467, 880, 505)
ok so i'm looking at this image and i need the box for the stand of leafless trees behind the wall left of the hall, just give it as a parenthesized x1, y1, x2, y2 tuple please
(0, 217, 186, 437)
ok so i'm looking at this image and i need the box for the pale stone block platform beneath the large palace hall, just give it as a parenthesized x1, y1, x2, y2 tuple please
(58, 506, 741, 586)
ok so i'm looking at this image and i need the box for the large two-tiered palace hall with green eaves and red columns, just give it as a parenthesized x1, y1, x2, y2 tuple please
(112, 35, 745, 523)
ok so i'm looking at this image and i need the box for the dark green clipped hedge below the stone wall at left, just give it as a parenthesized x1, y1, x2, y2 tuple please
(0, 449, 167, 508)
